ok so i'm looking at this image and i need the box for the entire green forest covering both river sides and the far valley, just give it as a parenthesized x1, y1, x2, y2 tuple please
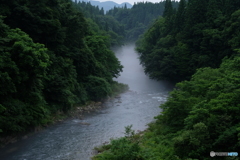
(0, 0, 240, 160)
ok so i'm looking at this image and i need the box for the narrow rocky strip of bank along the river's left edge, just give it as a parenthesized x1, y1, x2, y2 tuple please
(0, 83, 129, 148)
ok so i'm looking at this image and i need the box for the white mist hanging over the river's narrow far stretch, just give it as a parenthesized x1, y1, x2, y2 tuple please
(113, 43, 173, 92)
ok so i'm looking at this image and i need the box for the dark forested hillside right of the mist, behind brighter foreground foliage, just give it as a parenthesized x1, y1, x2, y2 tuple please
(137, 0, 240, 81)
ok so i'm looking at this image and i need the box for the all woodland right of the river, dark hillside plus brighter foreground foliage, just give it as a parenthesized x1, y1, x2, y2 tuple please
(94, 0, 240, 160)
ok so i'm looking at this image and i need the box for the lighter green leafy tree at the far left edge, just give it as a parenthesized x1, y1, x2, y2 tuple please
(0, 16, 49, 133)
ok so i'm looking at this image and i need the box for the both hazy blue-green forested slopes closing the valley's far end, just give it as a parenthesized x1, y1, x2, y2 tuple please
(75, 1, 179, 42)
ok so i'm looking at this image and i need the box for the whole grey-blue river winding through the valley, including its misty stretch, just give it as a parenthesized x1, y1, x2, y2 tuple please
(0, 44, 173, 160)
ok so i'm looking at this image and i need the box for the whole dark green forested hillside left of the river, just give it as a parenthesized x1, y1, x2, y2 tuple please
(0, 0, 123, 137)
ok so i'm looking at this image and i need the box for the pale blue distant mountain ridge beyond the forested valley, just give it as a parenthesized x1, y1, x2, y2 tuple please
(79, 0, 132, 13)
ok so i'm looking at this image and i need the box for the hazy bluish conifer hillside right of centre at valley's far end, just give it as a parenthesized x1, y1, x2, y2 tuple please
(106, 1, 178, 41)
